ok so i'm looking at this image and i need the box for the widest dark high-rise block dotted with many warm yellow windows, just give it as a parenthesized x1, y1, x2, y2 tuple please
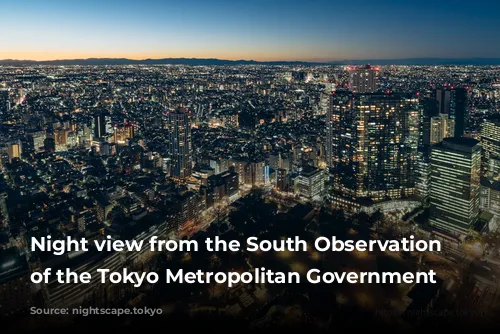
(326, 91, 419, 201)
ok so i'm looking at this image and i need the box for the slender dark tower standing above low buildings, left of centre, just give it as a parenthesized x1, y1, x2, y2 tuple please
(167, 108, 193, 179)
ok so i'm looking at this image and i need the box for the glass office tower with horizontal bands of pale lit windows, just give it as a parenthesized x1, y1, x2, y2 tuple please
(430, 138, 481, 236)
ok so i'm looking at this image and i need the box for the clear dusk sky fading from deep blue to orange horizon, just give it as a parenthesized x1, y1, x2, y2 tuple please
(0, 0, 500, 61)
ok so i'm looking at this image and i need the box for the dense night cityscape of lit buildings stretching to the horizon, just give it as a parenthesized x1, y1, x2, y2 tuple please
(0, 64, 500, 329)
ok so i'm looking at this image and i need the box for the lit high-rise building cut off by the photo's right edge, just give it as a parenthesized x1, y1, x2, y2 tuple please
(481, 118, 500, 180)
